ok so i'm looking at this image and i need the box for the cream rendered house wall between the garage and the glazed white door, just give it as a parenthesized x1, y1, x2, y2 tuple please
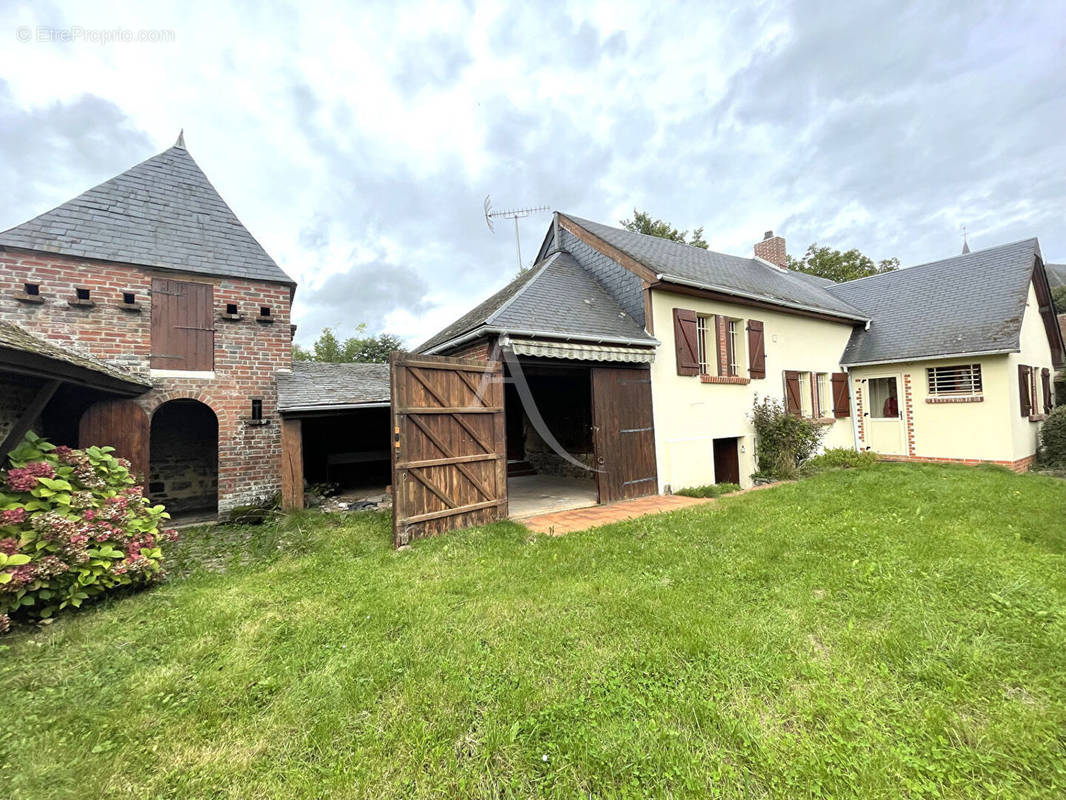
(651, 289, 855, 492)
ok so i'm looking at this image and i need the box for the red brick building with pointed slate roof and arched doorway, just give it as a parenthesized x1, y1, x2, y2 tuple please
(0, 137, 295, 514)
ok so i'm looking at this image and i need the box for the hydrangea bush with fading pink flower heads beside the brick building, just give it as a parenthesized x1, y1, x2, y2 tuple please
(0, 433, 177, 633)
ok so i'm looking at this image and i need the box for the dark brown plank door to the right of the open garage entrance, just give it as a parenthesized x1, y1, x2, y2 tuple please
(592, 367, 659, 502)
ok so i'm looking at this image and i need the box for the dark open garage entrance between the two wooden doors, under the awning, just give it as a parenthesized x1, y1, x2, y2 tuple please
(504, 359, 598, 518)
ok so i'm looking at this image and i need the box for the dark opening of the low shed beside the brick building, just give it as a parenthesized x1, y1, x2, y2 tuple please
(302, 407, 391, 500)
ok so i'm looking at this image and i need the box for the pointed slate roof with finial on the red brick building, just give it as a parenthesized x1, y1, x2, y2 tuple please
(0, 141, 295, 284)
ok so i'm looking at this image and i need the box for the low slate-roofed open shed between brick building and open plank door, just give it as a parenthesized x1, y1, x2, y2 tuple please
(277, 362, 392, 508)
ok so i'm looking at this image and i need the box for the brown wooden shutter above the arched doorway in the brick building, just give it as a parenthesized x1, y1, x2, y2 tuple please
(151, 277, 214, 371)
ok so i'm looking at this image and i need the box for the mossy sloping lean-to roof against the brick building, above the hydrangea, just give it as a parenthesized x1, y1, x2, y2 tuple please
(0, 322, 151, 396)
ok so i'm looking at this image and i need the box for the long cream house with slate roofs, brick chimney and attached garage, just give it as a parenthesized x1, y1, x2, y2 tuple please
(417, 212, 1064, 502)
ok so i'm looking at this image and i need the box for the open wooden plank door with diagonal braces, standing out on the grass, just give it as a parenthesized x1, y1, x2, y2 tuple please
(391, 353, 507, 547)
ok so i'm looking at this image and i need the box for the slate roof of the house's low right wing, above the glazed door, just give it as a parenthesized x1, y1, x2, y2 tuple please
(826, 239, 1040, 366)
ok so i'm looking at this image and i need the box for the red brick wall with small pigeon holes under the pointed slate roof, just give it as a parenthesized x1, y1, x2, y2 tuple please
(0, 249, 292, 511)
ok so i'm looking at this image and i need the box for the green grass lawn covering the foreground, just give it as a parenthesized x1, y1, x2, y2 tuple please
(0, 464, 1066, 800)
